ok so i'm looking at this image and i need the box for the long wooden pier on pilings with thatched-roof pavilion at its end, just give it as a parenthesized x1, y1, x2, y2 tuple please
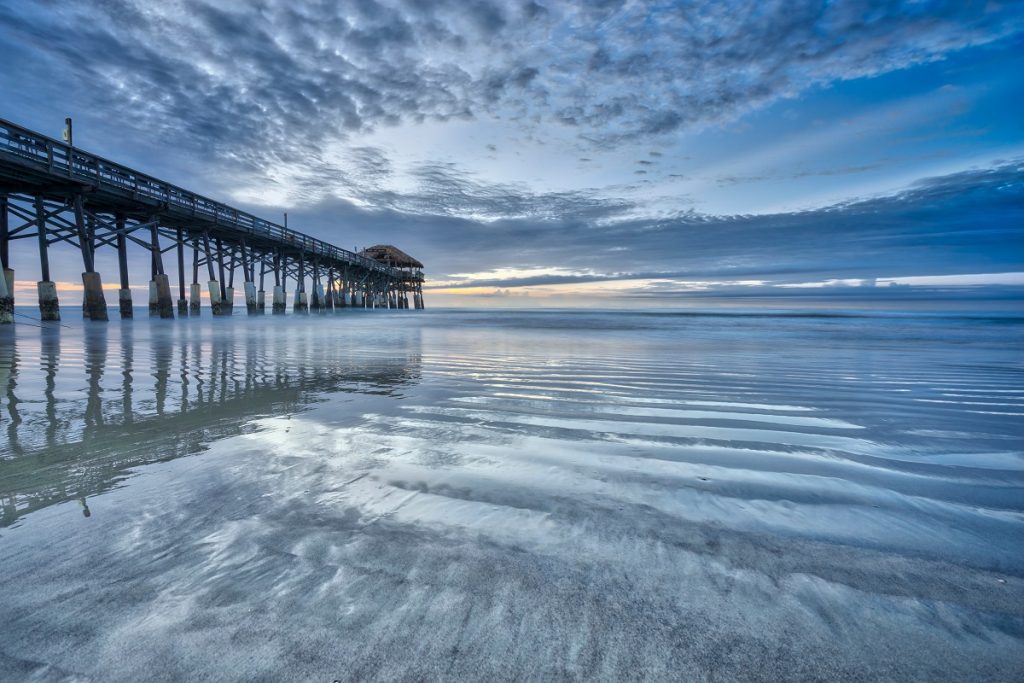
(0, 119, 424, 324)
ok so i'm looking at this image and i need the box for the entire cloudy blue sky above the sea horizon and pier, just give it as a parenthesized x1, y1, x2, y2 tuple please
(0, 0, 1024, 307)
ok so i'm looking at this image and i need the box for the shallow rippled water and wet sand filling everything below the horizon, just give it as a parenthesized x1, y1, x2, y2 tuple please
(0, 310, 1024, 681)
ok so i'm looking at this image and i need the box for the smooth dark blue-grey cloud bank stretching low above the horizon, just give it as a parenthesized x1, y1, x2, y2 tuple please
(290, 162, 1024, 287)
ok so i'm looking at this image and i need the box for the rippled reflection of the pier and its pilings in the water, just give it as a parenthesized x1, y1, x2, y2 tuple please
(0, 319, 421, 526)
